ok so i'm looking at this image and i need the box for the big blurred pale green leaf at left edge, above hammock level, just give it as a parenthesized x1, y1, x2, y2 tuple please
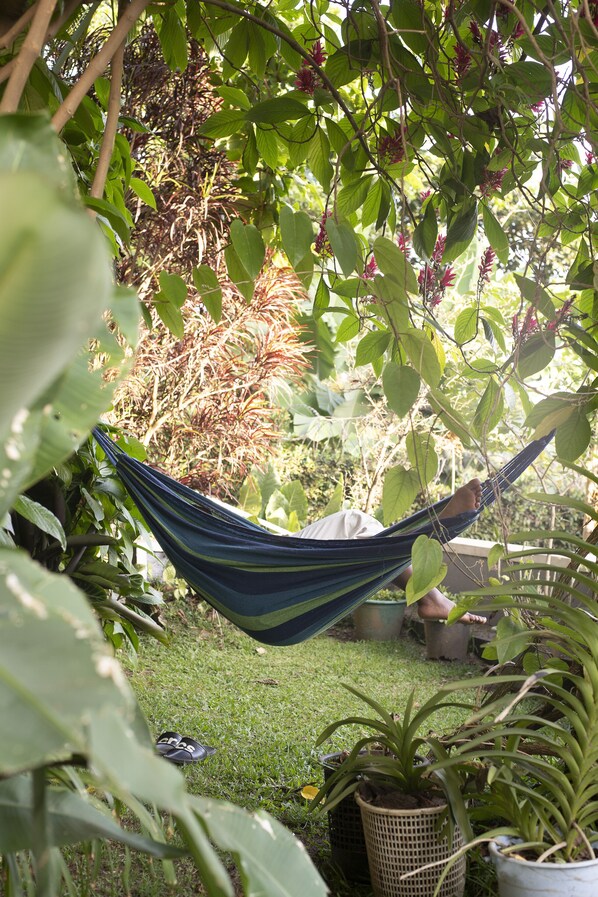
(0, 172, 111, 441)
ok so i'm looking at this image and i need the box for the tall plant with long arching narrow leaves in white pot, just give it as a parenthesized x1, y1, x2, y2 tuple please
(436, 497, 598, 897)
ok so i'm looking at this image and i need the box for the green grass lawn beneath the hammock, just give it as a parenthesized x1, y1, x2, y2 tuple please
(101, 600, 496, 897)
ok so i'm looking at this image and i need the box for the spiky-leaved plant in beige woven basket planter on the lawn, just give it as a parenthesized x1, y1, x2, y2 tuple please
(314, 685, 476, 897)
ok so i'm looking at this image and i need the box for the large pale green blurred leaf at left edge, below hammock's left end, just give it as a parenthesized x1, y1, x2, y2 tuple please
(0, 548, 141, 775)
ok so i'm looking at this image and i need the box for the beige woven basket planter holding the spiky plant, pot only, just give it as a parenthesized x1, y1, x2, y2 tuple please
(356, 794, 466, 897)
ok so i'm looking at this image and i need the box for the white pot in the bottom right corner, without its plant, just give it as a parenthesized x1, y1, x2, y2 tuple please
(490, 841, 598, 897)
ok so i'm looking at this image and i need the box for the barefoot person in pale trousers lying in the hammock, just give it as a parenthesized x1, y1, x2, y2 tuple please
(293, 477, 487, 623)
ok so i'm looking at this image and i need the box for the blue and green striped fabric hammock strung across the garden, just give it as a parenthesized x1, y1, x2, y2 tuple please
(94, 428, 552, 645)
